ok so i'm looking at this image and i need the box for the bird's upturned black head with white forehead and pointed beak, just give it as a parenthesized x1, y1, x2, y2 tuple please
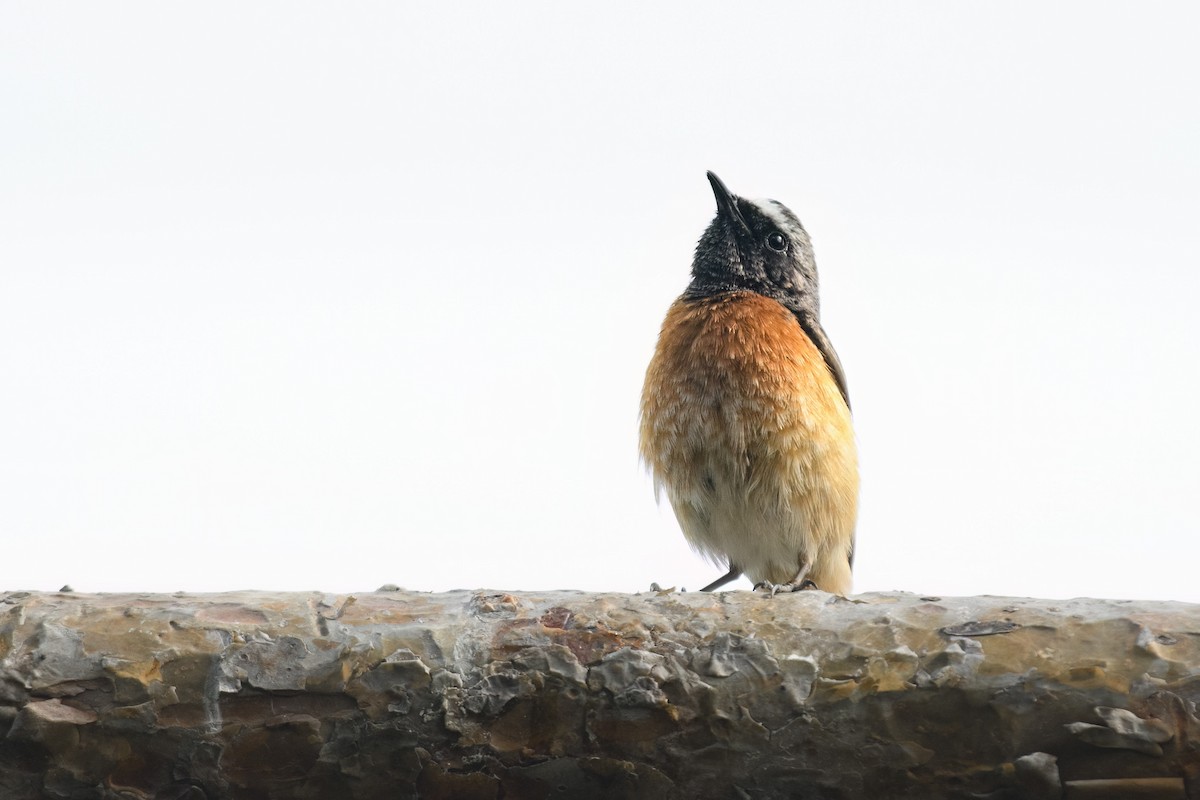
(691, 173, 817, 314)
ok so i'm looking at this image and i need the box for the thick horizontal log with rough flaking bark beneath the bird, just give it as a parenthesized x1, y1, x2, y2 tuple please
(0, 591, 1200, 800)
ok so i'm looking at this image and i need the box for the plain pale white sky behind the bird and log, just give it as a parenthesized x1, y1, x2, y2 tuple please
(0, 1, 1200, 601)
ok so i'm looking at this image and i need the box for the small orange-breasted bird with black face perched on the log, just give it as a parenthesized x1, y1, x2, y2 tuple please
(638, 172, 859, 596)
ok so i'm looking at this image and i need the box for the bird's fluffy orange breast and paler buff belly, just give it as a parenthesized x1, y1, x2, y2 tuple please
(640, 291, 858, 591)
